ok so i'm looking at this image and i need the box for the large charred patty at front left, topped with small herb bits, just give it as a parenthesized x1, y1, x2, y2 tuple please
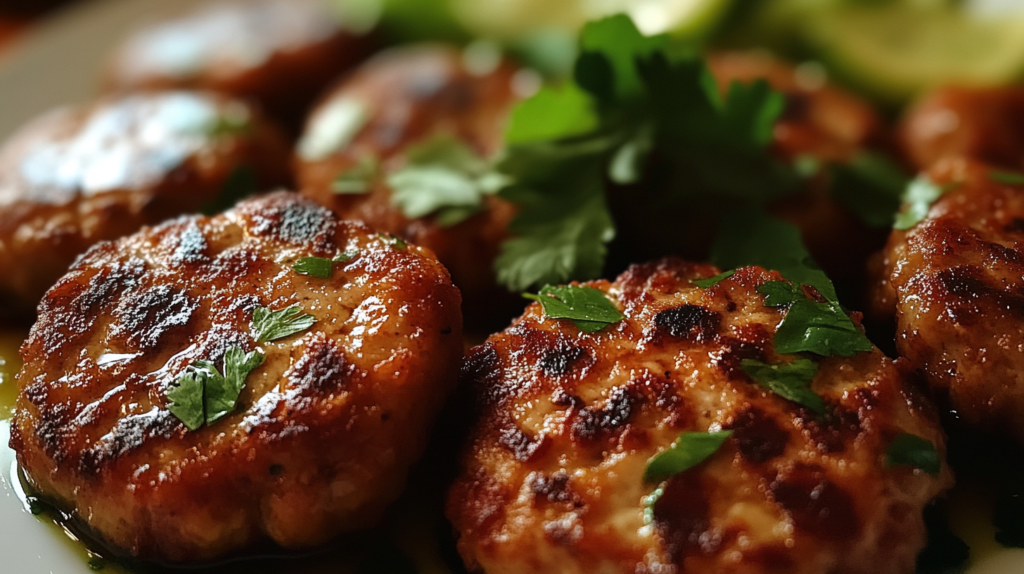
(11, 192, 462, 563)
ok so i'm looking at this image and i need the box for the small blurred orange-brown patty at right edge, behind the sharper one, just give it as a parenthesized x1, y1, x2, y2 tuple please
(899, 86, 1024, 170)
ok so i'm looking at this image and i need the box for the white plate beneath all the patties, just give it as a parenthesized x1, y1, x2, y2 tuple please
(0, 0, 1024, 574)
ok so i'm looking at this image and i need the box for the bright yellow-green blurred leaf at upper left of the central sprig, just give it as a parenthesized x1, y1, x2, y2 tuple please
(505, 84, 599, 145)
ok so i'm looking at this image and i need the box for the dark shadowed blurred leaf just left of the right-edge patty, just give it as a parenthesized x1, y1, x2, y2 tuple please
(829, 152, 910, 227)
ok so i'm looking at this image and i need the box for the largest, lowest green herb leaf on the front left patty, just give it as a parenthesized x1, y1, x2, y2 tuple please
(167, 347, 265, 431)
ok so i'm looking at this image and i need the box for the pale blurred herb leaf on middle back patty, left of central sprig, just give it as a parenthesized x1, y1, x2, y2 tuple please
(387, 136, 507, 225)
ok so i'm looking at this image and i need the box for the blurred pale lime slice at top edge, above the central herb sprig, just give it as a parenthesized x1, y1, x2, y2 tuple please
(452, 0, 732, 40)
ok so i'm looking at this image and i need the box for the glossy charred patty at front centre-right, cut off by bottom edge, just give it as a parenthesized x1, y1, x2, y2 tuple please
(447, 259, 951, 574)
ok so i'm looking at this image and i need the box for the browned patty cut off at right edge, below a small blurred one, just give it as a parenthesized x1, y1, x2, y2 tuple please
(874, 160, 1024, 442)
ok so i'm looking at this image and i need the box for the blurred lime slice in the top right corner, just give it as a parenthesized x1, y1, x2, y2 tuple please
(805, 0, 1024, 101)
